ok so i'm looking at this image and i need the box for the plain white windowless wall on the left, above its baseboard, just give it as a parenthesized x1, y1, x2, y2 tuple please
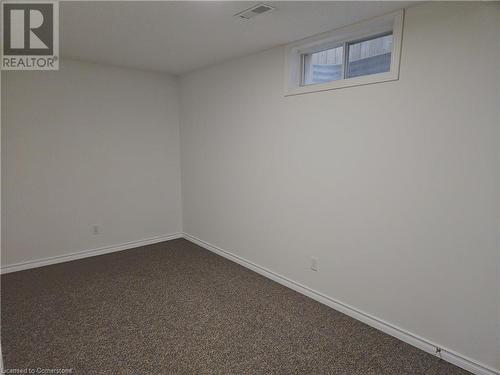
(2, 60, 182, 266)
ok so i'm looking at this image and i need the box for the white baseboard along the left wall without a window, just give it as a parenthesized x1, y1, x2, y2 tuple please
(1, 233, 183, 274)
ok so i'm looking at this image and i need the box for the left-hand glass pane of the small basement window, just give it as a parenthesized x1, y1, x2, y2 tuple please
(302, 46, 344, 85)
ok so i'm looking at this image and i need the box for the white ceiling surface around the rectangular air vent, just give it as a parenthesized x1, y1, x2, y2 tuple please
(60, 1, 410, 74)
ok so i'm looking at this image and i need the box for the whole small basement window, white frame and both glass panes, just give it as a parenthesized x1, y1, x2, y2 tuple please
(285, 10, 403, 96)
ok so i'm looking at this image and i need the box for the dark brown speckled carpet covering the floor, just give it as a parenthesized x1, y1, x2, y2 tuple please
(1, 239, 468, 375)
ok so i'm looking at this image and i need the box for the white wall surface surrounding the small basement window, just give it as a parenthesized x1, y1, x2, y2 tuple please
(180, 3, 500, 369)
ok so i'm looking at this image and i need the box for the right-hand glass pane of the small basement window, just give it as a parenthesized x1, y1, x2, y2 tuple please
(347, 34, 392, 78)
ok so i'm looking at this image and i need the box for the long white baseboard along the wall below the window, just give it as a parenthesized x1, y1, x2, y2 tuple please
(184, 233, 500, 375)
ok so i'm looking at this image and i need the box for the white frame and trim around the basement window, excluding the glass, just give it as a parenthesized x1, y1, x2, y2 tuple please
(285, 9, 404, 96)
